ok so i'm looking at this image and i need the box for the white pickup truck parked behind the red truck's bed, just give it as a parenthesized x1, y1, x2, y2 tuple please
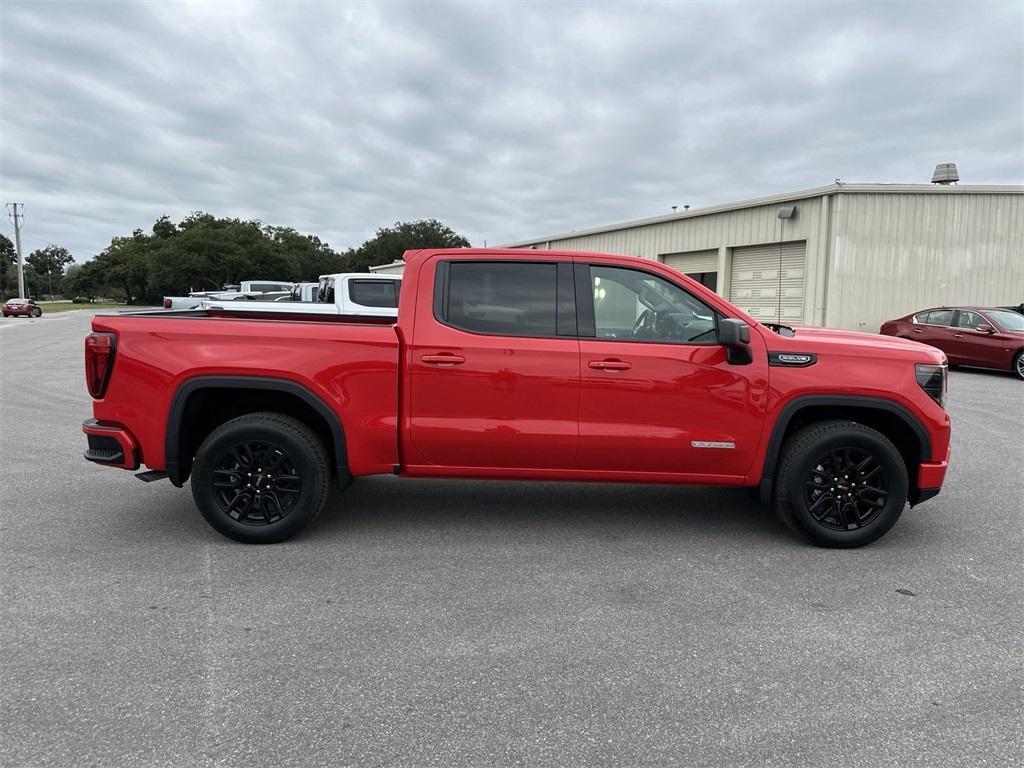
(202, 272, 401, 319)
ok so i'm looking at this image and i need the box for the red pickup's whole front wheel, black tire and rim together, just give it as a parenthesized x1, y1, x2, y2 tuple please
(774, 421, 908, 548)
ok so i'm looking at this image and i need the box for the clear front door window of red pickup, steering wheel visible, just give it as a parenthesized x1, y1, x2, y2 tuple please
(590, 266, 716, 344)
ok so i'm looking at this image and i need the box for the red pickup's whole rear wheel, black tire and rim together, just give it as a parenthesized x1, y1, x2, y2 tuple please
(191, 413, 331, 544)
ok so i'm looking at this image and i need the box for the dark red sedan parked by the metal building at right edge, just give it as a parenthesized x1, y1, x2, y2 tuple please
(881, 306, 1024, 379)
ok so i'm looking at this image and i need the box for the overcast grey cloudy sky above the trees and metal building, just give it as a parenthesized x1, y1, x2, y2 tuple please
(0, 0, 1024, 260)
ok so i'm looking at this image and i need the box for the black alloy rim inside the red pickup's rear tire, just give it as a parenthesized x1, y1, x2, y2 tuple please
(211, 440, 302, 525)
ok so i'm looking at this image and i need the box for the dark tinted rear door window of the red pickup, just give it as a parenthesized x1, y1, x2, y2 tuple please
(443, 261, 558, 337)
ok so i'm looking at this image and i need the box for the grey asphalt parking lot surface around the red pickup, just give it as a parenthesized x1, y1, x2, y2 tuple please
(0, 312, 1024, 768)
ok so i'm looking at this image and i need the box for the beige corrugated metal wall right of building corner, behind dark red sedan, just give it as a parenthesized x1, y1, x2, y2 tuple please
(824, 190, 1024, 332)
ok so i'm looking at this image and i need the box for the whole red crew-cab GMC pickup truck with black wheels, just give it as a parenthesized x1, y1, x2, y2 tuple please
(83, 249, 949, 547)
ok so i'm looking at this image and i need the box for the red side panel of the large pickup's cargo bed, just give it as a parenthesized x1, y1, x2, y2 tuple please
(92, 310, 399, 474)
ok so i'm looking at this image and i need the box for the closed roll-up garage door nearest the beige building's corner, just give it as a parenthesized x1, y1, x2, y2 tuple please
(729, 241, 807, 324)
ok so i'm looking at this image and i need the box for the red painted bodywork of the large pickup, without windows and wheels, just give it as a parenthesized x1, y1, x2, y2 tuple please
(86, 249, 949, 505)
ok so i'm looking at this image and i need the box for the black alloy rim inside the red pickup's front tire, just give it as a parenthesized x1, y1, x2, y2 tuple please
(804, 446, 889, 530)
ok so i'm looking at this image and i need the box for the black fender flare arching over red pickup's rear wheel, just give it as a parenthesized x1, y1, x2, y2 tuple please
(164, 376, 348, 487)
